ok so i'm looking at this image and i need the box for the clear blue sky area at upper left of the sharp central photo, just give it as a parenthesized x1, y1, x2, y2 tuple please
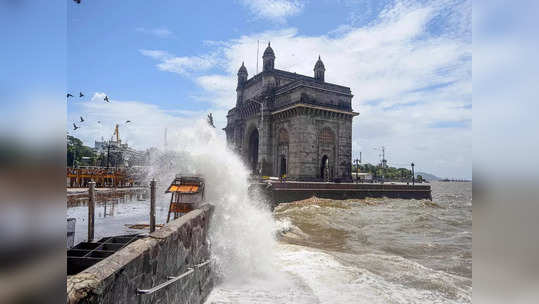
(67, 0, 386, 110)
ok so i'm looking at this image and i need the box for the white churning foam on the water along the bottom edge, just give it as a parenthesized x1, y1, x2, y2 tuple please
(206, 244, 470, 304)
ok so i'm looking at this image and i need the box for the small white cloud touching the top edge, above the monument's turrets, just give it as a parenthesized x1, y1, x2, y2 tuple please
(240, 0, 304, 22)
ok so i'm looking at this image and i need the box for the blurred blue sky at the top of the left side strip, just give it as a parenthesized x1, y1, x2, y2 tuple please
(0, 0, 67, 97)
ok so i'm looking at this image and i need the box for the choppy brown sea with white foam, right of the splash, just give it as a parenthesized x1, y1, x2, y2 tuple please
(206, 182, 472, 303)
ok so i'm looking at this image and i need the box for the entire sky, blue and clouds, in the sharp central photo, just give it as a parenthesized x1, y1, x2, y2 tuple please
(65, 0, 472, 178)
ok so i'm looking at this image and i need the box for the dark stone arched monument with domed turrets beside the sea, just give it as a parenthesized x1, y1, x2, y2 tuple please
(224, 44, 358, 181)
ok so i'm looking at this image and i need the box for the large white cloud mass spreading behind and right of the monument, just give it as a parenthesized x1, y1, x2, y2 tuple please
(139, 2, 472, 178)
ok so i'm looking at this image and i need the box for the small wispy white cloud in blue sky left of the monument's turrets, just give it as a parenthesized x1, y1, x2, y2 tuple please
(139, 50, 217, 75)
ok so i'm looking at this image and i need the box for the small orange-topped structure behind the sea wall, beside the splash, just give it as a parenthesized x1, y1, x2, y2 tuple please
(165, 176, 204, 223)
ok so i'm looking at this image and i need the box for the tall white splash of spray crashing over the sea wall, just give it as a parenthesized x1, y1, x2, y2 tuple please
(149, 120, 276, 281)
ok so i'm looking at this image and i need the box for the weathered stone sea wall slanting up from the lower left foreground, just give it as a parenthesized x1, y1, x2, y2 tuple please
(67, 205, 213, 304)
